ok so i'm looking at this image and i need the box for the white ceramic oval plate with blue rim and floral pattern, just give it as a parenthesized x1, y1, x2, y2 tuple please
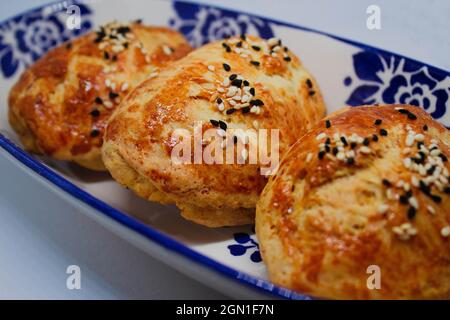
(0, 0, 450, 299)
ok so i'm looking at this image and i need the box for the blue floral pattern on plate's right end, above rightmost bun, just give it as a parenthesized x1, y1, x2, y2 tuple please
(344, 51, 450, 125)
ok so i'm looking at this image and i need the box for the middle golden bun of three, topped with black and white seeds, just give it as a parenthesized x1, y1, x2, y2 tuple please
(103, 36, 325, 227)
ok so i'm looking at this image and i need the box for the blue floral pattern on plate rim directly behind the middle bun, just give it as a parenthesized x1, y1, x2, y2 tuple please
(169, 2, 274, 47)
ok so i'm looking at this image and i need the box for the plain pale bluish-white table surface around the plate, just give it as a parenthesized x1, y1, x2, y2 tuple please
(0, 0, 450, 299)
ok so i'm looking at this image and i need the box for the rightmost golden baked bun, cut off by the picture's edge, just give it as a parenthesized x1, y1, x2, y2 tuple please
(256, 105, 450, 299)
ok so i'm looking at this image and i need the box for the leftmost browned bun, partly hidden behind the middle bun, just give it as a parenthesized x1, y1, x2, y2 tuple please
(9, 22, 191, 170)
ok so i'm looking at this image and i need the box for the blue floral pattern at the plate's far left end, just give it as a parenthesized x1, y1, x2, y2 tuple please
(0, 1, 92, 78)
